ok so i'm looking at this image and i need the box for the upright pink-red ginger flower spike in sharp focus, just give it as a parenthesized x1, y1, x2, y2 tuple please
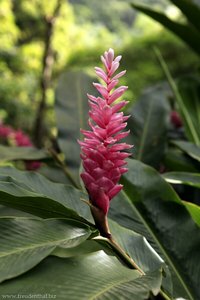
(79, 49, 132, 215)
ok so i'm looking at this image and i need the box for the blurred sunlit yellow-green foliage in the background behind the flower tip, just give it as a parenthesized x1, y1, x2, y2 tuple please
(0, 0, 199, 138)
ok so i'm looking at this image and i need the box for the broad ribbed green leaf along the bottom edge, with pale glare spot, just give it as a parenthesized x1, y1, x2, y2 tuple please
(0, 251, 162, 300)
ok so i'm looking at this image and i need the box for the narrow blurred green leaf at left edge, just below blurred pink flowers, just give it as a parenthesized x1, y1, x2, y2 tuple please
(0, 145, 49, 161)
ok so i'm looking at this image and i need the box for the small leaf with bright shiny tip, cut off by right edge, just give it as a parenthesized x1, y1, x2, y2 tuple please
(162, 172, 200, 188)
